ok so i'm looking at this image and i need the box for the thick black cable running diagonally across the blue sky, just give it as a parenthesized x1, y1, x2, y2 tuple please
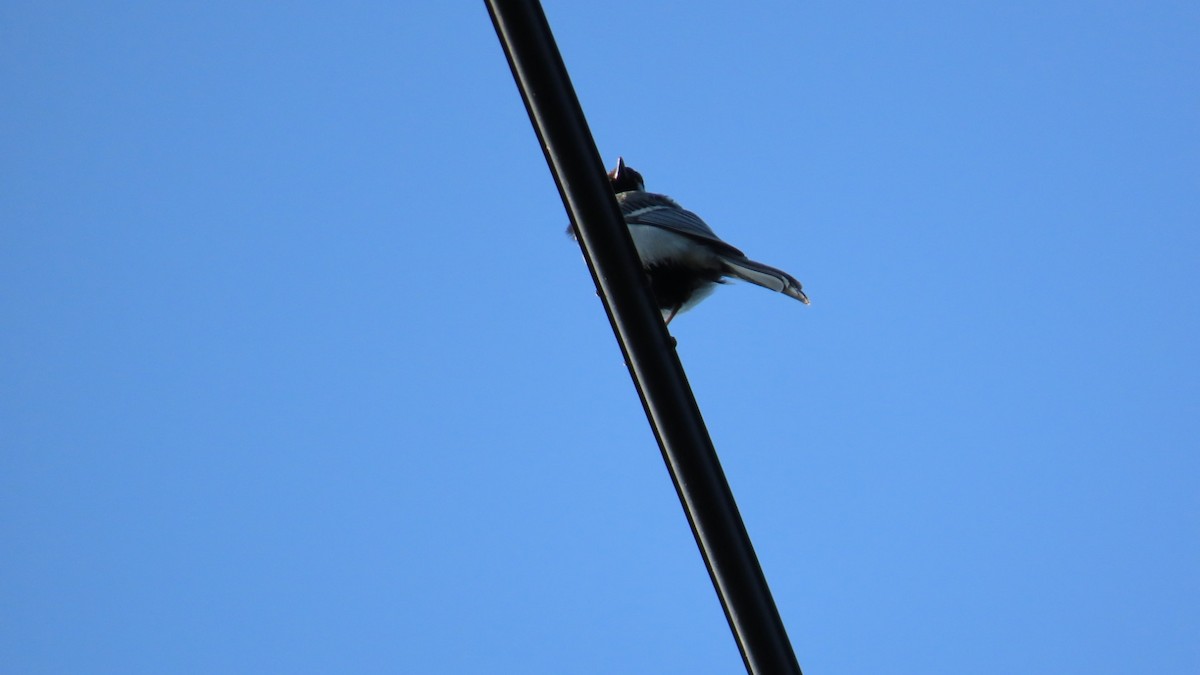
(486, 0, 800, 674)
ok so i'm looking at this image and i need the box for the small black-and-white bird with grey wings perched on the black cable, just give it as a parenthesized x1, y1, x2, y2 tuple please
(566, 157, 810, 324)
